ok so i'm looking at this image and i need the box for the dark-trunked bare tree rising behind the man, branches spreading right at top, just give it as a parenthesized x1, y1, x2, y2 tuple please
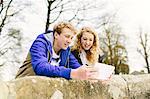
(45, 0, 102, 31)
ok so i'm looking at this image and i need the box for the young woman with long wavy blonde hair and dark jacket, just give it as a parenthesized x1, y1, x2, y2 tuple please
(72, 27, 99, 65)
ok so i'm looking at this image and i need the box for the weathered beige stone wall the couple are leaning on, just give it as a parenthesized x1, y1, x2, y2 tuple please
(0, 74, 150, 99)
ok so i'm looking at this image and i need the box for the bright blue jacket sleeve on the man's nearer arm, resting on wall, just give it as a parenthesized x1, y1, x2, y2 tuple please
(30, 40, 71, 79)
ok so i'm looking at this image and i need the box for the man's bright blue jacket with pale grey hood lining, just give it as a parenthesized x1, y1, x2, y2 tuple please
(30, 31, 80, 79)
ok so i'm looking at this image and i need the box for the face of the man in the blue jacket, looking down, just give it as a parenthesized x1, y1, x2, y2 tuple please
(55, 28, 74, 49)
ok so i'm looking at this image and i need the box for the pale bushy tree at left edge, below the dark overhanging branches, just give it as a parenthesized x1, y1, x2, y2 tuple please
(0, 29, 22, 66)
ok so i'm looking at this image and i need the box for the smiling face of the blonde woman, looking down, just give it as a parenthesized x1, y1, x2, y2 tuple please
(81, 32, 94, 50)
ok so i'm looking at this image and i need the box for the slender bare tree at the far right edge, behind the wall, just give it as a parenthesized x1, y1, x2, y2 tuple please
(137, 29, 150, 73)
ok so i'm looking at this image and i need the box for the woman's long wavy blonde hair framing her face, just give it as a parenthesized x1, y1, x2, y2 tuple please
(72, 27, 99, 64)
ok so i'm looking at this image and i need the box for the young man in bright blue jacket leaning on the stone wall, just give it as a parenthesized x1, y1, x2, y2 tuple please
(16, 22, 93, 79)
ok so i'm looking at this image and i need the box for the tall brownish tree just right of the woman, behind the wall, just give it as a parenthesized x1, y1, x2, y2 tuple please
(98, 14, 129, 74)
